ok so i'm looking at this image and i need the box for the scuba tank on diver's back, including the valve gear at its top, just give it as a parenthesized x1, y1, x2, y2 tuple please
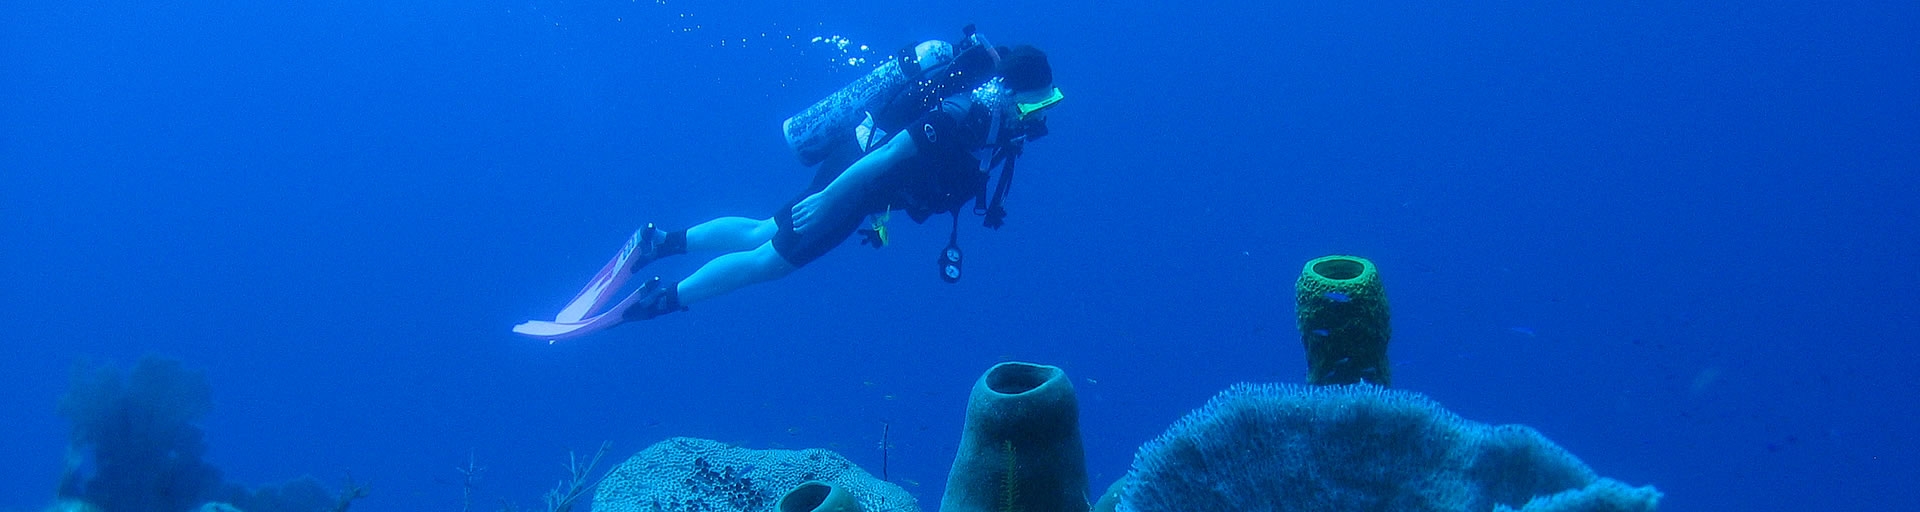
(780, 25, 998, 167)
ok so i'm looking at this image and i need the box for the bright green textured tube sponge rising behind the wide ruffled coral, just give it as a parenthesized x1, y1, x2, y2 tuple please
(1294, 255, 1394, 385)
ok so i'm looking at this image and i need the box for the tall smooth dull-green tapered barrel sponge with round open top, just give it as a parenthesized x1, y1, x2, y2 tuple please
(941, 362, 1091, 512)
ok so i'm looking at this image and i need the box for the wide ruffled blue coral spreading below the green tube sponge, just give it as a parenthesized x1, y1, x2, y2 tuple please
(1117, 384, 1659, 512)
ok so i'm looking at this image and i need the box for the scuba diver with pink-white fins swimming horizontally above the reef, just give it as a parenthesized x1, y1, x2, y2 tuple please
(513, 25, 1064, 341)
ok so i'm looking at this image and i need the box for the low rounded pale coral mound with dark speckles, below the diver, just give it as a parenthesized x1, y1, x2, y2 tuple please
(593, 437, 920, 512)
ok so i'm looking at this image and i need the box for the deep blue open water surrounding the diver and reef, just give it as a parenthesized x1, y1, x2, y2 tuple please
(0, 0, 1920, 510)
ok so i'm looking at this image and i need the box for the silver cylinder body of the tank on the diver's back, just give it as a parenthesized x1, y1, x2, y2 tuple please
(780, 40, 954, 167)
